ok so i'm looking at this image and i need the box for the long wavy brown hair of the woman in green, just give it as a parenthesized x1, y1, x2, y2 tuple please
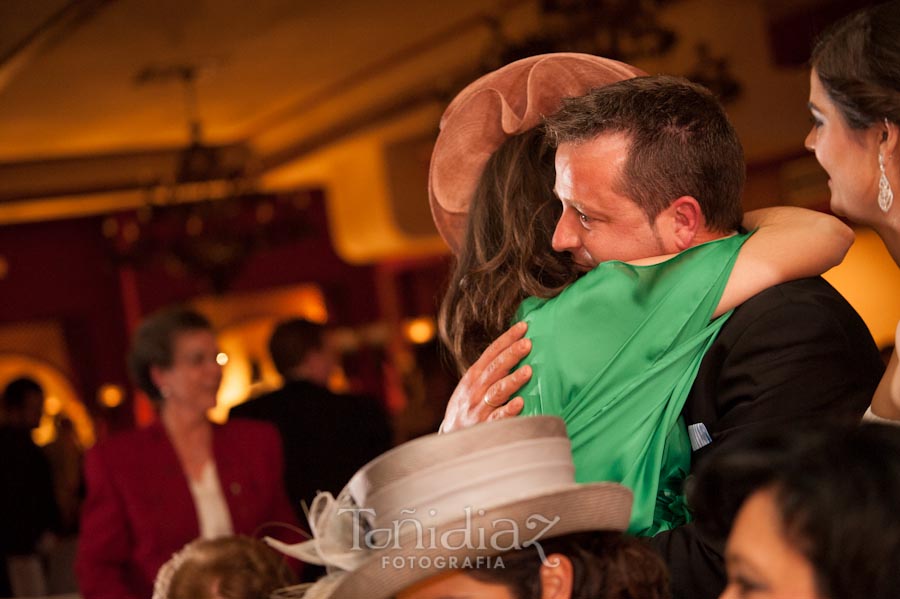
(438, 128, 577, 372)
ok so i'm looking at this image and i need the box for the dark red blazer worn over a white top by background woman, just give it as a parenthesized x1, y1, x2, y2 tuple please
(75, 421, 296, 599)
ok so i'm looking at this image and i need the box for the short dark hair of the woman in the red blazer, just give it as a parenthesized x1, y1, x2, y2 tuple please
(128, 307, 212, 402)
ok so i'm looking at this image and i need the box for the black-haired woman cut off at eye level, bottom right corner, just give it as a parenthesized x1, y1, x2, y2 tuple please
(693, 423, 900, 599)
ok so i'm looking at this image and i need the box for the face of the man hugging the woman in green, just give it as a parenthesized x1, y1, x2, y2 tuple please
(553, 133, 672, 271)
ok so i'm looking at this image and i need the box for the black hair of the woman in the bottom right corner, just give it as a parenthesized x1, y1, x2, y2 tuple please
(691, 424, 900, 599)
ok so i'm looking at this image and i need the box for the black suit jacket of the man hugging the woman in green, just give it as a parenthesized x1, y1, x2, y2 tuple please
(651, 277, 884, 599)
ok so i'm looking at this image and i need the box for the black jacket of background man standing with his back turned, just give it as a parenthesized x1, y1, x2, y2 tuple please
(229, 381, 391, 522)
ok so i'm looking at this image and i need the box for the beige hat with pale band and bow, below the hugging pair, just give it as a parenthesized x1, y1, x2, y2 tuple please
(267, 416, 632, 599)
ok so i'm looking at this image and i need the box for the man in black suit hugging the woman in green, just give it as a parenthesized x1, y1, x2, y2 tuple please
(441, 77, 883, 599)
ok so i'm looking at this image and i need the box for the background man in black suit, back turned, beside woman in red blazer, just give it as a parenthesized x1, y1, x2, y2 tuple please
(229, 318, 391, 521)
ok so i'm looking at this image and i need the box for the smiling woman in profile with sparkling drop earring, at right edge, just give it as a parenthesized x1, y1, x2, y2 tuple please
(806, 0, 900, 420)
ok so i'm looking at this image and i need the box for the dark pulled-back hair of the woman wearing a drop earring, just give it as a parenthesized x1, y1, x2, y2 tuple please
(810, 0, 900, 129)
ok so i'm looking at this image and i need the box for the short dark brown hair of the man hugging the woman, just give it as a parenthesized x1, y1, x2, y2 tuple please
(546, 75, 746, 232)
